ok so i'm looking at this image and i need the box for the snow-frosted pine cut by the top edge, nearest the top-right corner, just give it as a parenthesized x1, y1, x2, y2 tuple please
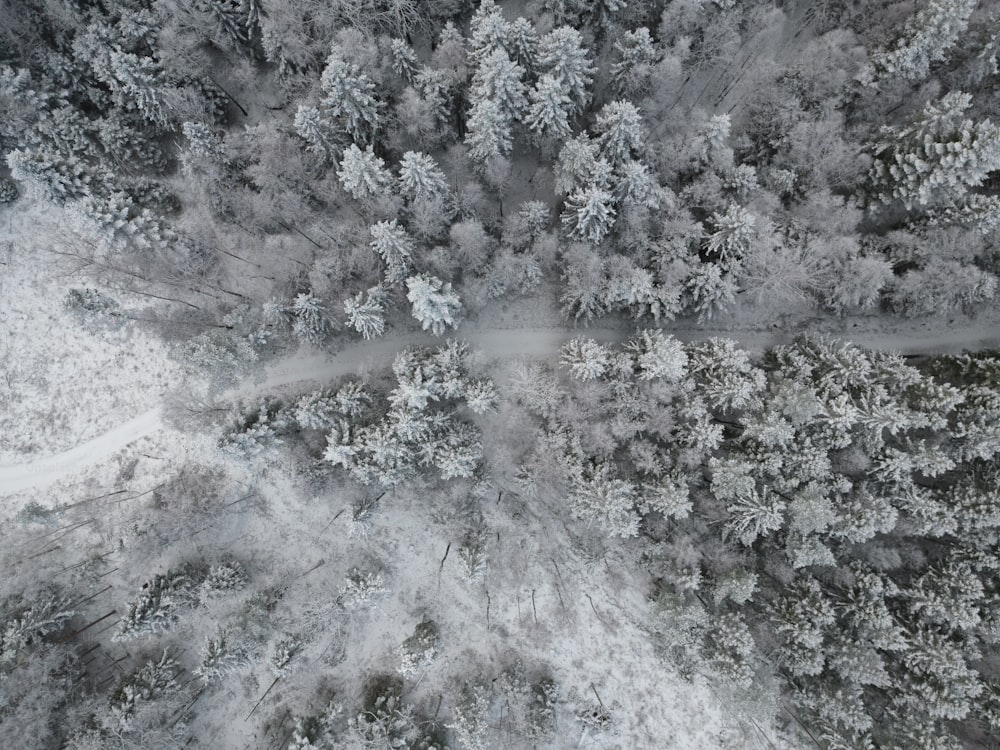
(861, 0, 978, 85)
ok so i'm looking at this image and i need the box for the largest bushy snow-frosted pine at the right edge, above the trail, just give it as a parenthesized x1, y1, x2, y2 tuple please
(870, 91, 1000, 209)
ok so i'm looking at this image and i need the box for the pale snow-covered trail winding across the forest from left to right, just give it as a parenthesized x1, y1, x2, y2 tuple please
(0, 324, 1000, 496)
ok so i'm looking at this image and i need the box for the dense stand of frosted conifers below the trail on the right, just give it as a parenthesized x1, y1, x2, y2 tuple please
(521, 331, 1000, 749)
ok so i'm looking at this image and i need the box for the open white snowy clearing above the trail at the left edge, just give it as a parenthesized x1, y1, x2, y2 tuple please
(0, 206, 180, 464)
